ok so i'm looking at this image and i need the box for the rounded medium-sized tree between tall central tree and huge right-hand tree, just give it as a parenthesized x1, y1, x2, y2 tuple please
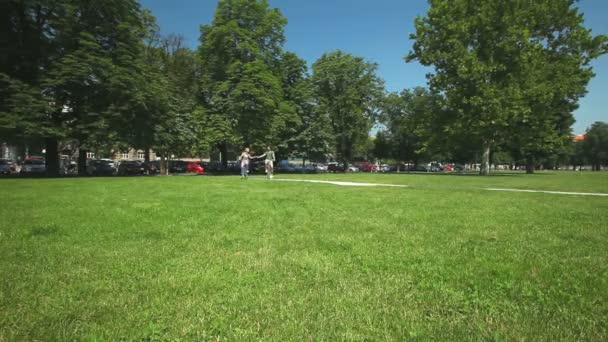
(312, 51, 383, 168)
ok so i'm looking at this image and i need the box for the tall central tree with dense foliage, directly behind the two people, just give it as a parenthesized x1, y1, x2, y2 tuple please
(199, 0, 292, 163)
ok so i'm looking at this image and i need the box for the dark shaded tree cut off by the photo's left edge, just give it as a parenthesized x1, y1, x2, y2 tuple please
(0, 0, 65, 170)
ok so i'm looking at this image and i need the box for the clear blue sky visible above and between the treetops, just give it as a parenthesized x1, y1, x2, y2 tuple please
(140, 0, 608, 133)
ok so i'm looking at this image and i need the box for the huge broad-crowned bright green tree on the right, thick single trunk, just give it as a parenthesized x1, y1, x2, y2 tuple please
(407, 0, 606, 174)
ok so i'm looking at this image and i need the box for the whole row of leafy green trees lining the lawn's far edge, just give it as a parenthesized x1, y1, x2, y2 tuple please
(0, 0, 607, 175)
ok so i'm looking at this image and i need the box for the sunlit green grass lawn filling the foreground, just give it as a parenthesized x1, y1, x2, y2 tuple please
(0, 172, 608, 341)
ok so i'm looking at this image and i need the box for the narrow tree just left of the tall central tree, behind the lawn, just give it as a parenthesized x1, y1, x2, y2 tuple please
(132, 35, 201, 174)
